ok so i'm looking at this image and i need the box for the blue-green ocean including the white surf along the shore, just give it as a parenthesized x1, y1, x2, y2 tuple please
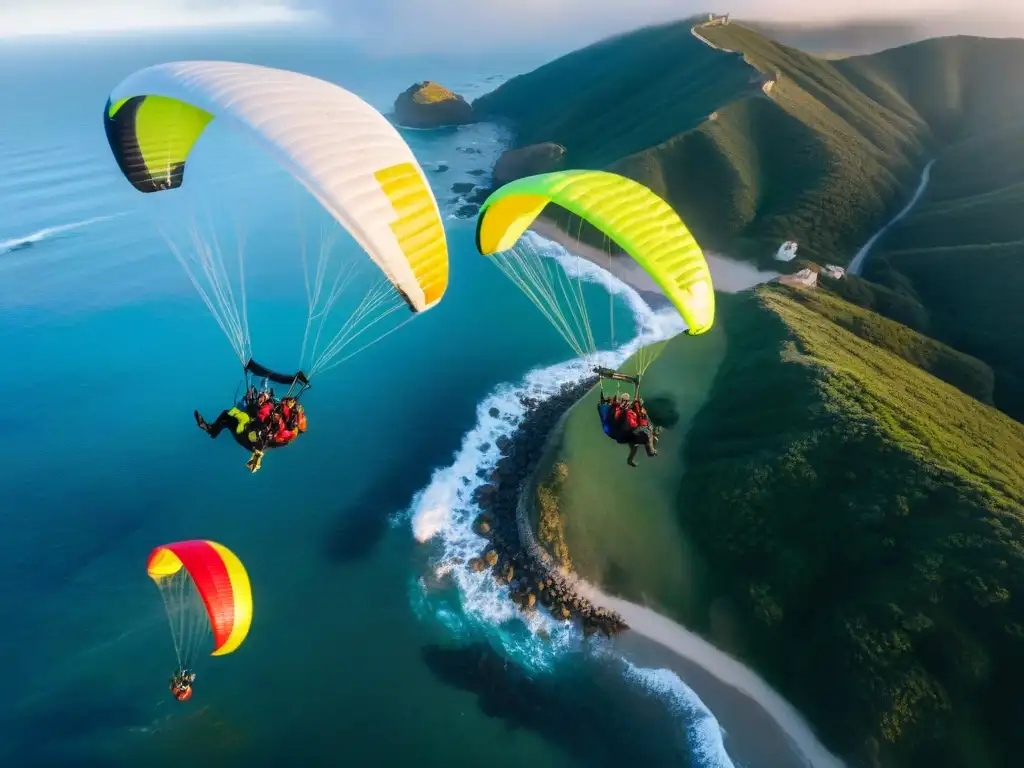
(0, 34, 731, 766)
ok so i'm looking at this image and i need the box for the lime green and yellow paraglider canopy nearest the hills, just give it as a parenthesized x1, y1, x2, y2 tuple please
(476, 170, 715, 344)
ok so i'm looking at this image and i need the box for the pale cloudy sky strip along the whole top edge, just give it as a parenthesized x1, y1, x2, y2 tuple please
(0, 0, 1024, 53)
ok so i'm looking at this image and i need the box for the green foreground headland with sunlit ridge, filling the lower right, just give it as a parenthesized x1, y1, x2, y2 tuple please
(536, 287, 1024, 768)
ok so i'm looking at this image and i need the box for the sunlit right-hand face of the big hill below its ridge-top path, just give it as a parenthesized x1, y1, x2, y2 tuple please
(616, 25, 928, 263)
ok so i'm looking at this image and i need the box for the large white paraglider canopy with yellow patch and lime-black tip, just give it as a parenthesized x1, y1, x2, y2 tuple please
(103, 61, 449, 312)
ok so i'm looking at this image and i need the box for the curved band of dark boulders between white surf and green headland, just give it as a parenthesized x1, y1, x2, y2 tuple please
(467, 377, 629, 637)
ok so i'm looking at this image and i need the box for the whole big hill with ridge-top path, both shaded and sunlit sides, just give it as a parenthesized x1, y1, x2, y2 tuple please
(474, 22, 927, 263)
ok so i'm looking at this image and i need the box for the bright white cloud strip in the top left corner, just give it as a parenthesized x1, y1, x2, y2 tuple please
(0, 0, 318, 38)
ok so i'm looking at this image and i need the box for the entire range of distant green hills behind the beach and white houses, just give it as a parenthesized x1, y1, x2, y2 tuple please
(474, 22, 1024, 420)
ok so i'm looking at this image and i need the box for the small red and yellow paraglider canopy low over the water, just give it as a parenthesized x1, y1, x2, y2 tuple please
(145, 540, 253, 656)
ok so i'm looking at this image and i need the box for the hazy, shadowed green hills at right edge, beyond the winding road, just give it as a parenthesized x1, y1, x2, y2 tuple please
(841, 38, 1024, 419)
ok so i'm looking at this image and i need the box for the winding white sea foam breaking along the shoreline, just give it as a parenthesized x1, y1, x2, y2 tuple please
(411, 232, 732, 767)
